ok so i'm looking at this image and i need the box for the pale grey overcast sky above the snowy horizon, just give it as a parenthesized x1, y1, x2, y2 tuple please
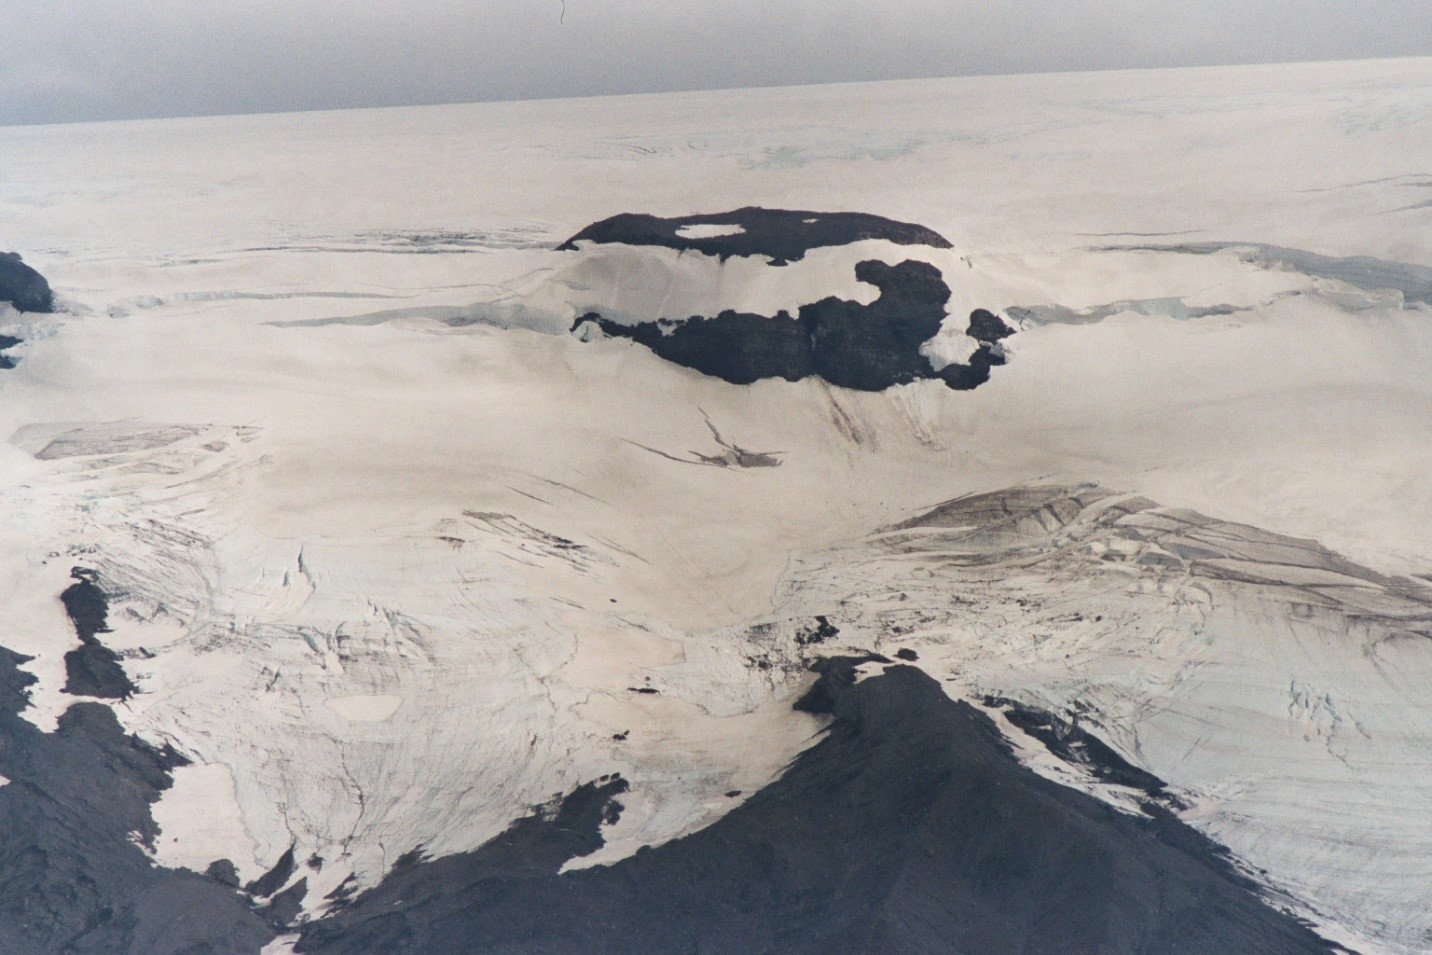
(0, 0, 1432, 125)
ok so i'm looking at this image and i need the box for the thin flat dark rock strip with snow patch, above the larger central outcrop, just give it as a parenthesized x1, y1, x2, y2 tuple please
(557, 206, 949, 265)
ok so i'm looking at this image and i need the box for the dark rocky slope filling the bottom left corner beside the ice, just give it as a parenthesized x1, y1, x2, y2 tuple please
(0, 647, 274, 955)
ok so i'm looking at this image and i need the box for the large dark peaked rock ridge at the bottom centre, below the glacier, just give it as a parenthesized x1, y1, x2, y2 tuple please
(298, 659, 1339, 955)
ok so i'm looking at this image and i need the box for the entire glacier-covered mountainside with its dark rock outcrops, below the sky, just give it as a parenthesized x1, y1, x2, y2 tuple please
(0, 59, 1432, 955)
